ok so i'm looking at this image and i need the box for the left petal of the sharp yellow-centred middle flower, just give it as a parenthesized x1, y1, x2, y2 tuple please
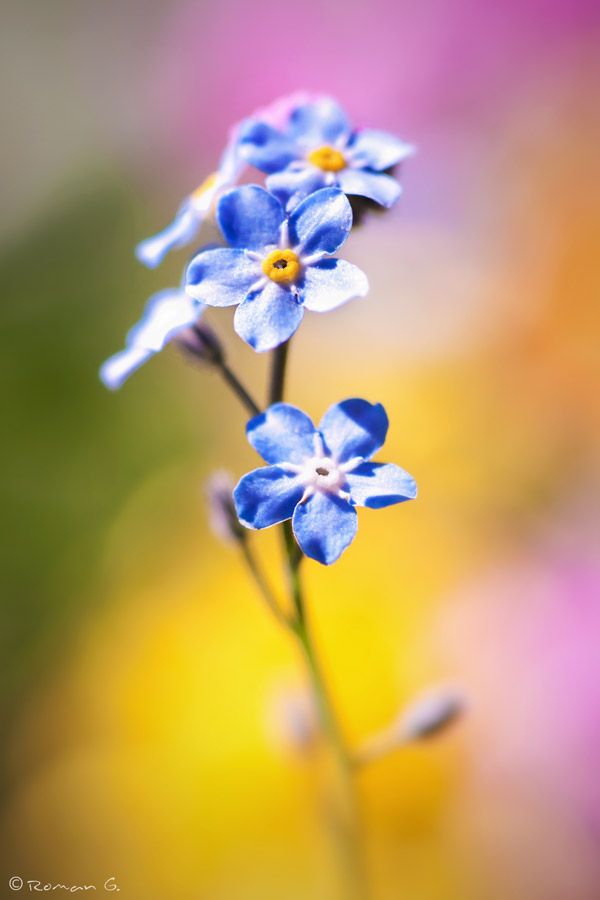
(185, 247, 263, 306)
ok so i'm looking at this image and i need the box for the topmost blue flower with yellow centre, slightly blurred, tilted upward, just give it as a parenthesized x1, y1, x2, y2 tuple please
(239, 97, 414, 207)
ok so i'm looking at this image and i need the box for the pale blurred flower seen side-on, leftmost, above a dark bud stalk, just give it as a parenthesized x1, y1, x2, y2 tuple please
(100, 288, 204, 391)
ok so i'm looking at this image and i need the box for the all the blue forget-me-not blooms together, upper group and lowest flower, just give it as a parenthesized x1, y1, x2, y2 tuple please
(100, 93, 416, 564)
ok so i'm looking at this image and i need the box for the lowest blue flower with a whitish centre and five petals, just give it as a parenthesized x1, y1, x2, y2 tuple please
(233, 399, 417, 565)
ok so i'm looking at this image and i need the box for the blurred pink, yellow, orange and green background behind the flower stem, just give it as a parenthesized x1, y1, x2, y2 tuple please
(0, 0, 600, 900)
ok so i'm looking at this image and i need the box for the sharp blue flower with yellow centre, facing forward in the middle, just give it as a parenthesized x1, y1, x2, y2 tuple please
(186, 185, 369, 352)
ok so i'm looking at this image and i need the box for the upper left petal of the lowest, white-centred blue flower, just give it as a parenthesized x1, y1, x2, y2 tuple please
(246, 403, 317, 465)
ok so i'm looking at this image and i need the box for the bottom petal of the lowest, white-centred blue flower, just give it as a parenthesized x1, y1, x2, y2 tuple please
(292, 491, 358, 566)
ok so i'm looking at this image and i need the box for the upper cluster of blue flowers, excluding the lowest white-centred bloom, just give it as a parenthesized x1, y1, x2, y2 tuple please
(101, 92, 413, 389)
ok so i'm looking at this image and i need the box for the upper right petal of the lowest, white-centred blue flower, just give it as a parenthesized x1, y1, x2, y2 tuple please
(319, 399, 388, 462)
